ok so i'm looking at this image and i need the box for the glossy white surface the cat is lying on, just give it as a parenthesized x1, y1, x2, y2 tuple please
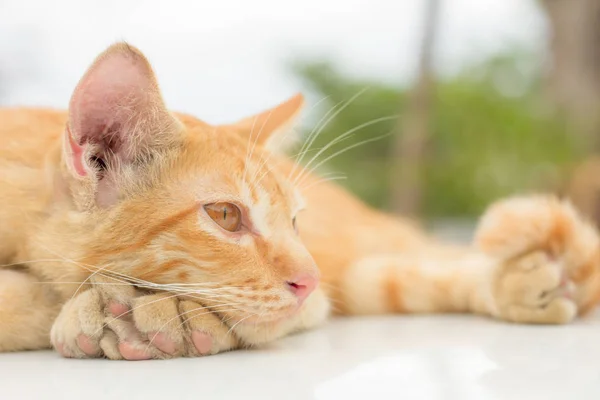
(0, 314, 600, 400)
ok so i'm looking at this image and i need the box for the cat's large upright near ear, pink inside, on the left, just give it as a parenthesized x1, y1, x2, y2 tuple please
(64, 43, 180, 207)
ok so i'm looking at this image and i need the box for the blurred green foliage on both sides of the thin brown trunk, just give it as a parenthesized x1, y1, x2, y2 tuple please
(294, 51, 585, 218)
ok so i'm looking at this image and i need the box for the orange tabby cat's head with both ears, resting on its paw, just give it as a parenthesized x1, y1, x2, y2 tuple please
(57, 44, 319, 322)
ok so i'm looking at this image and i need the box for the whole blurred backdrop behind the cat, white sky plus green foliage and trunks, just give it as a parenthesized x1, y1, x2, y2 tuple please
(0, 0, 600, 228)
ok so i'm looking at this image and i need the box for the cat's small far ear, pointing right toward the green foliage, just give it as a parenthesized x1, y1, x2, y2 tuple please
(228, 93, 304, 153)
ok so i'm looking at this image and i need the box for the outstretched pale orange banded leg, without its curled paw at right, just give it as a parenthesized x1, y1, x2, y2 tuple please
(340, 246, 498, 315)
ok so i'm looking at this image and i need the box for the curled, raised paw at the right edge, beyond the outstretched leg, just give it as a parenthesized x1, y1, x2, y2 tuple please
(476, 196, 600, 324)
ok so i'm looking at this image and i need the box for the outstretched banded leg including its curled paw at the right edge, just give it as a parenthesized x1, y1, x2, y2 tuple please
(340, 197, 600, 323)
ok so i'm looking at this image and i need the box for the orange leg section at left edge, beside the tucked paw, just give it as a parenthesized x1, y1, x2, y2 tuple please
(0, 270, 60, 352)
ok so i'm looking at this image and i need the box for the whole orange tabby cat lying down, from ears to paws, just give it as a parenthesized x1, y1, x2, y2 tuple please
(0, 44, 600, 360)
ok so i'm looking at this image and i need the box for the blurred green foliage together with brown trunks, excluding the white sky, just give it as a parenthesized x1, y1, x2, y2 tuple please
(291, 0, 600, 225)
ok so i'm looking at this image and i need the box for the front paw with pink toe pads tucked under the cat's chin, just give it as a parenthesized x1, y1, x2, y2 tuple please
(51, 287, 237, 360)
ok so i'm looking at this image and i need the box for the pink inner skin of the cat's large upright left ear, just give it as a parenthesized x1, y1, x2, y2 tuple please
(69, 46, 159, 167)
